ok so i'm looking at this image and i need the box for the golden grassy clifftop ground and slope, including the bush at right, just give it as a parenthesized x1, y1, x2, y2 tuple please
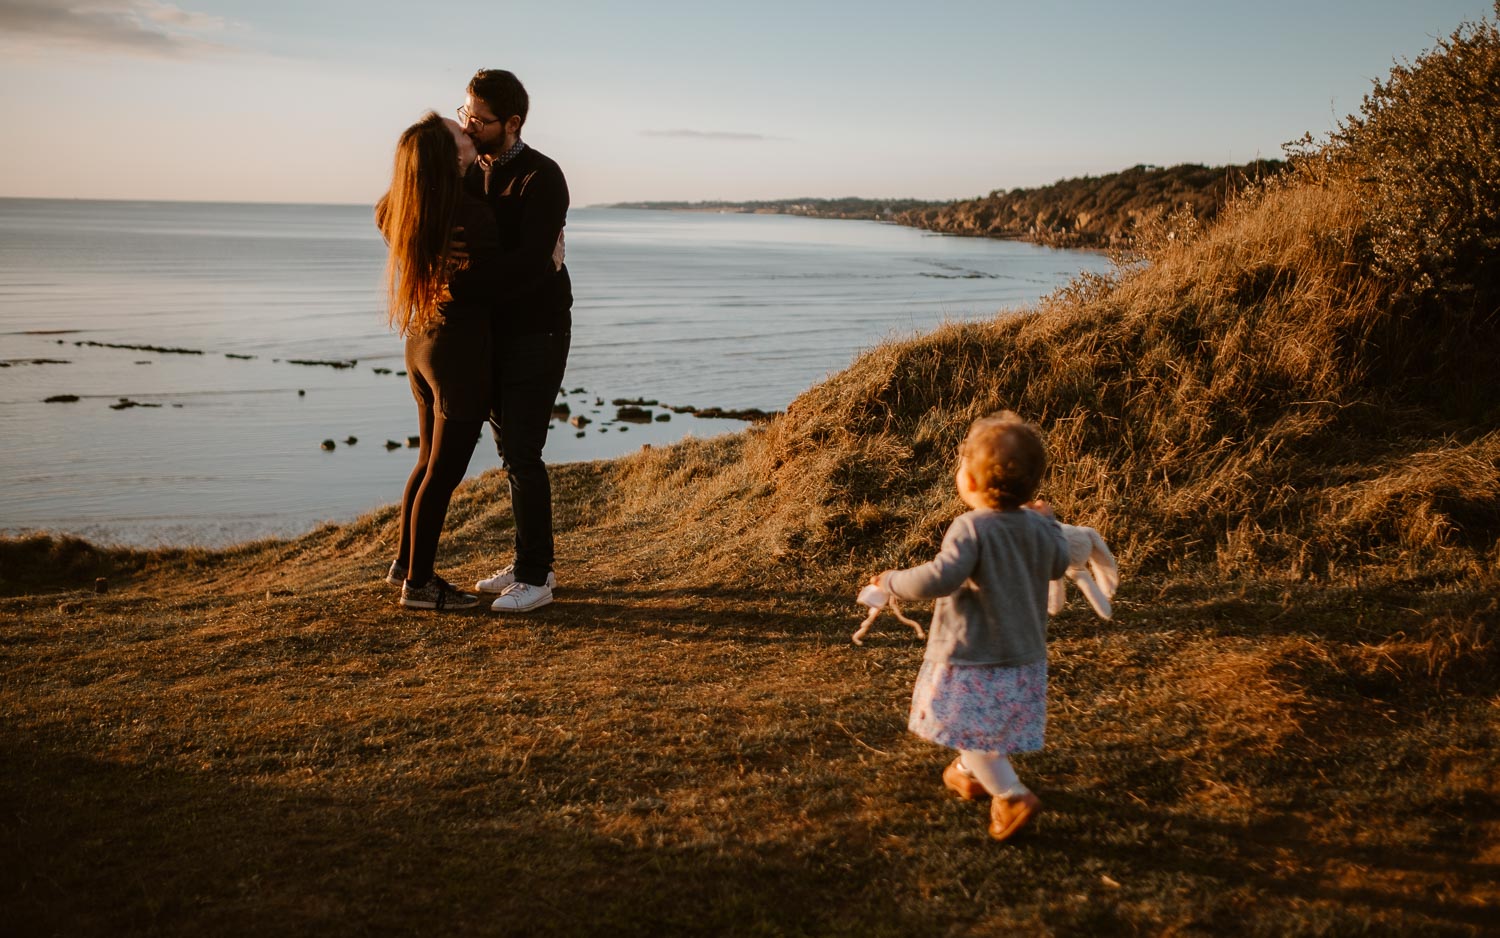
(0, 9, 1500, 935)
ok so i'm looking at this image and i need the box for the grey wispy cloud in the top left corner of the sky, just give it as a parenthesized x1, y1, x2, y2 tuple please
(0, 0, 230, 59)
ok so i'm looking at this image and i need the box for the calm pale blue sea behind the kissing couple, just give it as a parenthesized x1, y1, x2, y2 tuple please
(0, 200, 1109, 545)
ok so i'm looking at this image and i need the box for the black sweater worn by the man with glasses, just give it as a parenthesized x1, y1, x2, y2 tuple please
(464, 147, 573, 342)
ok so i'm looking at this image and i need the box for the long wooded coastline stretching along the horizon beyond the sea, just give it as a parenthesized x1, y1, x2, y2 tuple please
(600, 159, 1283, 248)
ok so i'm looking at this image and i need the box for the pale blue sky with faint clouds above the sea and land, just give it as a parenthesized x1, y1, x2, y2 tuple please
(0, 0, 1494, 206)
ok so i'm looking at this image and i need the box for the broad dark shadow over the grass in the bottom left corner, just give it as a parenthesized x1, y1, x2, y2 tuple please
(0, 738, 924, 935)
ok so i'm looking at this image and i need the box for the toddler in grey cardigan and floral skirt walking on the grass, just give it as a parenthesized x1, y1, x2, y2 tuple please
(872, 411, 1068, 840)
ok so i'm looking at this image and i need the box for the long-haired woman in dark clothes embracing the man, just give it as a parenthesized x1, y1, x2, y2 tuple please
(375, 111, 500, 609)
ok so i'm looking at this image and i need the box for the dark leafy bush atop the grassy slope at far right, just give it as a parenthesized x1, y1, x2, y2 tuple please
(1295, 3, 1500, 411)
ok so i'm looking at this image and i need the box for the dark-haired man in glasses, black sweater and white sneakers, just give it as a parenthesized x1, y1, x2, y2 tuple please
(459, 69, 573, 612)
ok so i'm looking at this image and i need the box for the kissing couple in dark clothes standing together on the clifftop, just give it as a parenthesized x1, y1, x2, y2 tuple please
(375, 69, 573, 612)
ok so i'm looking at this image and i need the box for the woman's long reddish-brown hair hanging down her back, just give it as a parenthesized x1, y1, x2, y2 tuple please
(375, 111, 464, 336)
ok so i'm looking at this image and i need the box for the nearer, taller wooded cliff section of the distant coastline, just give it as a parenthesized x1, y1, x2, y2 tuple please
(891, 159, 1283, 248)
